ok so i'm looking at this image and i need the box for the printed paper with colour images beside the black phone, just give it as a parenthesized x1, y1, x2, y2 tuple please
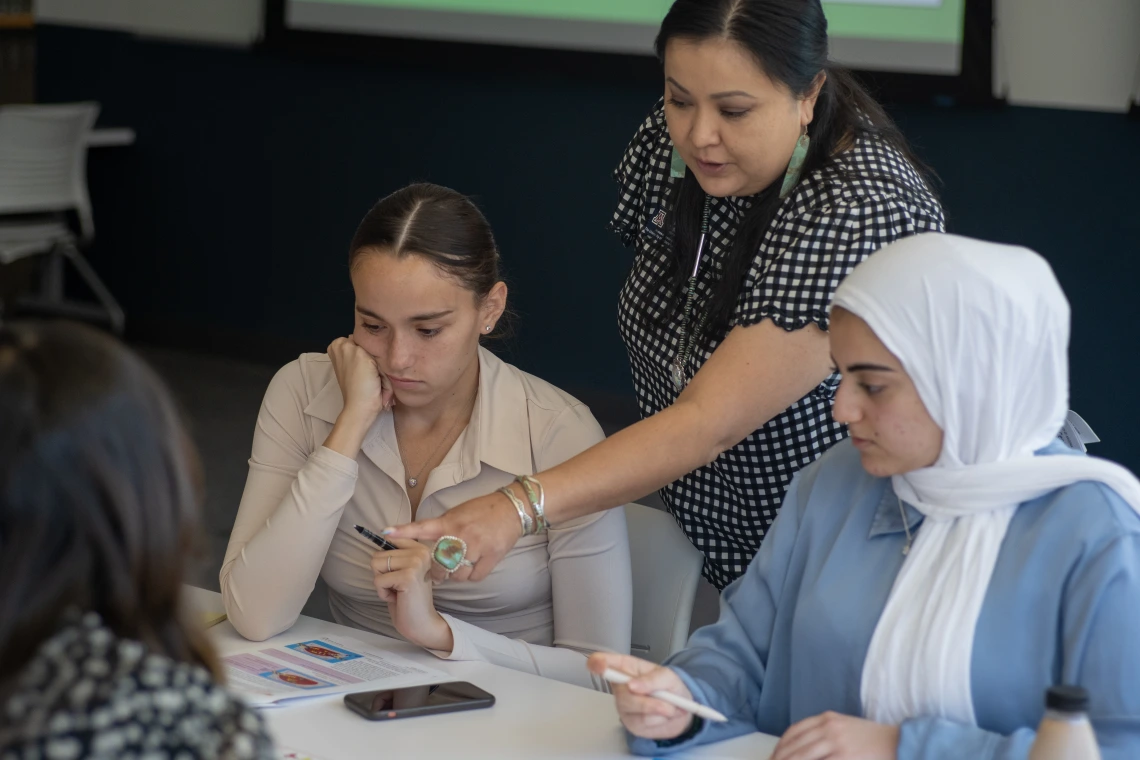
(222, 636, 450, 706)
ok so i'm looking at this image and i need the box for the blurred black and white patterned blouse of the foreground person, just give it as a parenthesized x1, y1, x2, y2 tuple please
(0, 613, 275, 760)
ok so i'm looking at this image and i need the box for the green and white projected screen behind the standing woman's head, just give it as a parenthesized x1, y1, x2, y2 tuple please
(286, 0, 967, 74)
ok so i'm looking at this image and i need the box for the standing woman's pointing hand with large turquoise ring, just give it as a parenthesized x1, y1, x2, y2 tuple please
(383, 492, 521, 581)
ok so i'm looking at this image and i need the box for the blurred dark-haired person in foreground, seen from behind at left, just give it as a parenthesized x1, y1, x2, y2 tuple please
(0, 322, 275, 760)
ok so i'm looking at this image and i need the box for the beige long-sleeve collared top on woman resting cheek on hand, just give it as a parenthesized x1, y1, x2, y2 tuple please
(221, 349, 633, 689)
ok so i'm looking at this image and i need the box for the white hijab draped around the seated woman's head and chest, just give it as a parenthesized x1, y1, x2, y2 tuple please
(833, 234, 1140, 725)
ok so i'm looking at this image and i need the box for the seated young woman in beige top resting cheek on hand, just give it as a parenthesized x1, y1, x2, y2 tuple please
(221, 185, 633, 689)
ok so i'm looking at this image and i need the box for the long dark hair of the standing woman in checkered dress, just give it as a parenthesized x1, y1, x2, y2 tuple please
(656, 0, 926, 332)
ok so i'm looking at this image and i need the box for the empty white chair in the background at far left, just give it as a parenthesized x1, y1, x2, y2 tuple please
(0, 103, 124, 333)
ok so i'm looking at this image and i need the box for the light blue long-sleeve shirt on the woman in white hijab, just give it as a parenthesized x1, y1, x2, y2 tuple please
(629, 441, 1140, 760)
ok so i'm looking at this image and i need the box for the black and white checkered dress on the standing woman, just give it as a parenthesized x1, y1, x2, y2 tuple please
(611, 101, 944, 589)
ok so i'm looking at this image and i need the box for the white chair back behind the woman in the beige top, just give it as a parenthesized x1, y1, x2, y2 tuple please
(626, 504, 705, 662)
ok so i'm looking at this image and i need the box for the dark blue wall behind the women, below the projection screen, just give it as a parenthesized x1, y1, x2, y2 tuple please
(39, 27, 1140, 469)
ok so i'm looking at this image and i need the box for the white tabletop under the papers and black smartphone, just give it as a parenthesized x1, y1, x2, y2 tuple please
(187, 588, 776, 760)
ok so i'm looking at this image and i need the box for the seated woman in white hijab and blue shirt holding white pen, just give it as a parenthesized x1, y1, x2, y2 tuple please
(591, 235, 1140, 760)
